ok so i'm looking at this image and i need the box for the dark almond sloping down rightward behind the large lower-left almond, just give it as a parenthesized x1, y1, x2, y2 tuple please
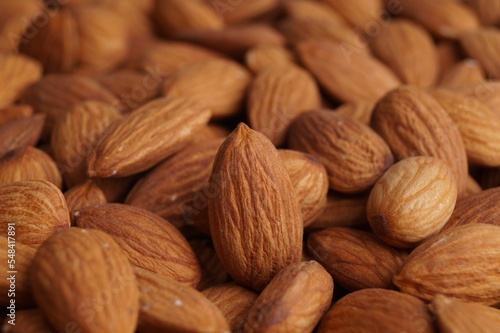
(75, 204, 201, 287)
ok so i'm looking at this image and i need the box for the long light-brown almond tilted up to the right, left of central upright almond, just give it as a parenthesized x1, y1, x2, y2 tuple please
(88, 97, 211, 178)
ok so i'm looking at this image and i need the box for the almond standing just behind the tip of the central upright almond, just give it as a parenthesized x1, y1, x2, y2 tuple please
(247, 66, 320, 146)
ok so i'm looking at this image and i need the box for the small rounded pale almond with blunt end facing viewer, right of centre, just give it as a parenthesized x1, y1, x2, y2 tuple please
(366, 156, 457, 248)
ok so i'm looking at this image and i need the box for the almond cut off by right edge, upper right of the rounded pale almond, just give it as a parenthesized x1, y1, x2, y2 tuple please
(431, 89, 500, 167)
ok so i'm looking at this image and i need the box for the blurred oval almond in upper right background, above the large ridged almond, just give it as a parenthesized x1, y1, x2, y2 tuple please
(371, 20, 439, 87)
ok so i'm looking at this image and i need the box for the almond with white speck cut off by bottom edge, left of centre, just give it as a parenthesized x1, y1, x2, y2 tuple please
(135, 267, 230, 333)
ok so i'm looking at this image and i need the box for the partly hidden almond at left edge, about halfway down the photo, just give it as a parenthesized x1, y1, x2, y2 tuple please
(0, 146, 62, 188)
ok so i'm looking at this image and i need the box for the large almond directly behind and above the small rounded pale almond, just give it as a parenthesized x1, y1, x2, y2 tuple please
(371, 86, 468, 195)
